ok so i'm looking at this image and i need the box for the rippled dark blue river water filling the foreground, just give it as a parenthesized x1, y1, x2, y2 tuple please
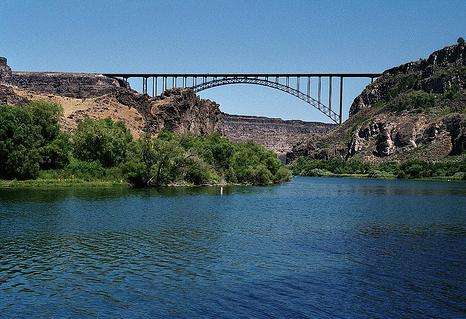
(0, 177, 466, 318)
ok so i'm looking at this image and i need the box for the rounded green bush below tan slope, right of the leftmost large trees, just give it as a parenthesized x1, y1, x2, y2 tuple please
(73, 118, 132, 167)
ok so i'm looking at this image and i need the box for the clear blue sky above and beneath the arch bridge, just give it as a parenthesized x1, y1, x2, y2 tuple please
(0, 0, 466, 122)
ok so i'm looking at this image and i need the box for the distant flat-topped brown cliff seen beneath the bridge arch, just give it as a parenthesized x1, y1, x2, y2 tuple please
(220, 113, 335, 155)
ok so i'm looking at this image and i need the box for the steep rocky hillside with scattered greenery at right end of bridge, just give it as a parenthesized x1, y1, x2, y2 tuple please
(287, 45, 466, 162)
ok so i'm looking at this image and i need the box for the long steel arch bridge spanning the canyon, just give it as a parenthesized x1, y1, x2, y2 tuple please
(104, 73, 381, 124)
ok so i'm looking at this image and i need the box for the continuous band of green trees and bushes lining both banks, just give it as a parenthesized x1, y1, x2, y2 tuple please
(0, 102, 466, 189)
